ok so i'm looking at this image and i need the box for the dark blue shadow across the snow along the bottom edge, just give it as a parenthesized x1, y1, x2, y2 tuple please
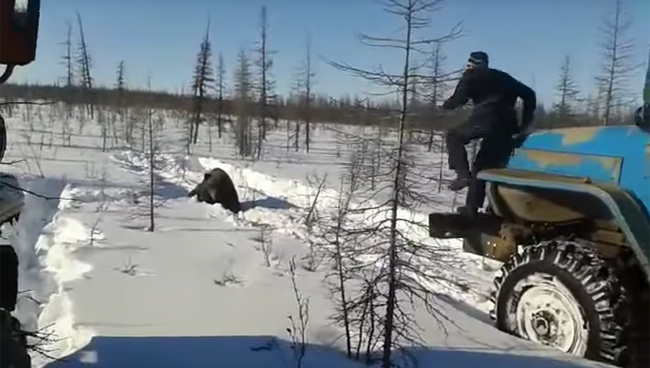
(46, 336, 596, 368)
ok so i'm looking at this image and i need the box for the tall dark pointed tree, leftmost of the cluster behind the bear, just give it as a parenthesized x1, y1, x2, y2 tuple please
(189, 21, 214, 144)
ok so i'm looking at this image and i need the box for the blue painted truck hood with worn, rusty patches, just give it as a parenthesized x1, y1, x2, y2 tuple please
(508, 126, 650, 213)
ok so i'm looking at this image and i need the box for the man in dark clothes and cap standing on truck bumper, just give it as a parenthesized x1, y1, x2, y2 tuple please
(442, 51, 537, 215)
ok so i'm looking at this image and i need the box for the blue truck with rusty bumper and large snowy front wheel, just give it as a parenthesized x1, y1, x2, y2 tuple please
(429, 50, 650, 368)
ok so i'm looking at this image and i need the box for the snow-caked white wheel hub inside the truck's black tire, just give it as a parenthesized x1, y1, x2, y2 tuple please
(516, 276, 588, 355)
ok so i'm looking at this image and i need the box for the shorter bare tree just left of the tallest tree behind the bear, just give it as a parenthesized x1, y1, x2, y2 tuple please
(234, 49, 254, 157)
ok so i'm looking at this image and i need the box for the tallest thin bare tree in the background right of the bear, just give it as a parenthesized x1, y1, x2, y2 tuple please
(255, 5, 275, 160)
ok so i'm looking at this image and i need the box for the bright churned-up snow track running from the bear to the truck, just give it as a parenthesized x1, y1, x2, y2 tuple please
(113, 151, 494, 313)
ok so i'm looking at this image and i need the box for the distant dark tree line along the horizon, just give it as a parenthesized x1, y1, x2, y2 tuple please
(0, 0, 640, 137)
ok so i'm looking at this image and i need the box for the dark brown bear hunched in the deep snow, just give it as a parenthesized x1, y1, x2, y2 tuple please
(188, 168, 241, 214)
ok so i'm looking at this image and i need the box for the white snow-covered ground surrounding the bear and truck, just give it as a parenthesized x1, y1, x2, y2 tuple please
(3, 106, 601, 368)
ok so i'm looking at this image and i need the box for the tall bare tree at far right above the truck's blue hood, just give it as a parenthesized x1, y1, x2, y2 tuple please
(596, 0, 638, 125)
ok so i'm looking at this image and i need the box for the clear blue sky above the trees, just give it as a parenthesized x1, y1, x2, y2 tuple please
(8, 0, 650, 103)
